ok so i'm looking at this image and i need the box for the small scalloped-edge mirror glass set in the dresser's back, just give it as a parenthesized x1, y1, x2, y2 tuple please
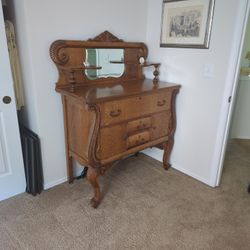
(83, 48, 124, 80)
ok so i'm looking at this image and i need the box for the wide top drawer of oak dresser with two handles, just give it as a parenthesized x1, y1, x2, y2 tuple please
(101, 91, 171, 126)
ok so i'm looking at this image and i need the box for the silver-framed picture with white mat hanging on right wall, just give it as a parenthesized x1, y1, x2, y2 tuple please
(160, 0, 215, 49)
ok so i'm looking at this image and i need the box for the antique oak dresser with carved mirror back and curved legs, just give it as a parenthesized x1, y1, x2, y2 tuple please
(50, 31, 180, 207)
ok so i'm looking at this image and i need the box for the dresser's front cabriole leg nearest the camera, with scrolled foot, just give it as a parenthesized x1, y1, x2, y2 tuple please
(87, 167, 101, 208)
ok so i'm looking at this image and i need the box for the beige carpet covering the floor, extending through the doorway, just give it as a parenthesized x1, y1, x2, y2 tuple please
(0, 141, 250, 250)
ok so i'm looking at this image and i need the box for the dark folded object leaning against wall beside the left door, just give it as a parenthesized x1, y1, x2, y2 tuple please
(20, 125, 43, 196)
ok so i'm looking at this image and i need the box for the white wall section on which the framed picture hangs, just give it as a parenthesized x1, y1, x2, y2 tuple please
(144, 0, 245, 185)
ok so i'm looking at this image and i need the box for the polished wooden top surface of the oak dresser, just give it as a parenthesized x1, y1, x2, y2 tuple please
(56, 79, 180, 104)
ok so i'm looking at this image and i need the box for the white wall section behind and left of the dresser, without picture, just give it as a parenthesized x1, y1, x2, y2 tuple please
(10, 0, 147, 188)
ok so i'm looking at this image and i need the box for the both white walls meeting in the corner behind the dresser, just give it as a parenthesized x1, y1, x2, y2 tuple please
(10, 0, 246, 187)
